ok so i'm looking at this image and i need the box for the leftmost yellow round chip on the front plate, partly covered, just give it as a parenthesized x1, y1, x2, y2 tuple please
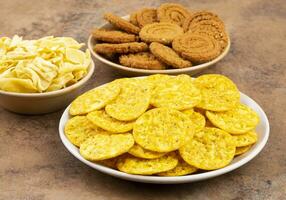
(65, 116, 108, 147)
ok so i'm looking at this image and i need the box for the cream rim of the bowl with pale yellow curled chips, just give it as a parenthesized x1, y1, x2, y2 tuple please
(0, 59, 95, 97)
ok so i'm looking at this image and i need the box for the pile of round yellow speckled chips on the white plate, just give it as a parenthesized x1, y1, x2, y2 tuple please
(65, 74, 259, 176)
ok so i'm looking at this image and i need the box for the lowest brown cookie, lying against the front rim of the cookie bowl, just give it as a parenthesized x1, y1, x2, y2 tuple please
(119, 52, 166, 70)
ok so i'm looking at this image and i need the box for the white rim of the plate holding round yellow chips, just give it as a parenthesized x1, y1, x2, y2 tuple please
(59, 77, 270, 184)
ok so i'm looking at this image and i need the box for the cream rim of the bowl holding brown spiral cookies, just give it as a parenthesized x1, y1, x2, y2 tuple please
(87, 15, 231, 74)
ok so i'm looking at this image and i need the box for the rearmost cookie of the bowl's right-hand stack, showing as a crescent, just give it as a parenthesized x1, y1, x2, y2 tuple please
(183, 11, 224, 32)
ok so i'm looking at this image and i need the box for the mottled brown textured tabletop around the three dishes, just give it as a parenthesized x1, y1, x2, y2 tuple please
(0, 0, 286, 200)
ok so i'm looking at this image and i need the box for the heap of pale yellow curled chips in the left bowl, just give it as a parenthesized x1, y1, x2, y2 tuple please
(0, 35, 91, 93)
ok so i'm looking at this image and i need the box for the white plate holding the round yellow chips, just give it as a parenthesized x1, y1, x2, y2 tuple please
(59, 78, 269, 184)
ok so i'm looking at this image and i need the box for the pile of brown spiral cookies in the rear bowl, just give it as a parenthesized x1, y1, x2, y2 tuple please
(92, 3, 228, 70)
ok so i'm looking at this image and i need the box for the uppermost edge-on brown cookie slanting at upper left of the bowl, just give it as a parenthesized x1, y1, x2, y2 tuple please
(104, 13, 140, 34)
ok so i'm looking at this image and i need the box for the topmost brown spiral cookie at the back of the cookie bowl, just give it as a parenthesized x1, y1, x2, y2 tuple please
(158, 3, 191, 26)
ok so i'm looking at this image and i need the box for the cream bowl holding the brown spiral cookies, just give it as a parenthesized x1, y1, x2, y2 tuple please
(88, 15, 231, 76)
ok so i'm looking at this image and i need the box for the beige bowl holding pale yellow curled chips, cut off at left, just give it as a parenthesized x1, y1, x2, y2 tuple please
(0, 60, 94, 115)
